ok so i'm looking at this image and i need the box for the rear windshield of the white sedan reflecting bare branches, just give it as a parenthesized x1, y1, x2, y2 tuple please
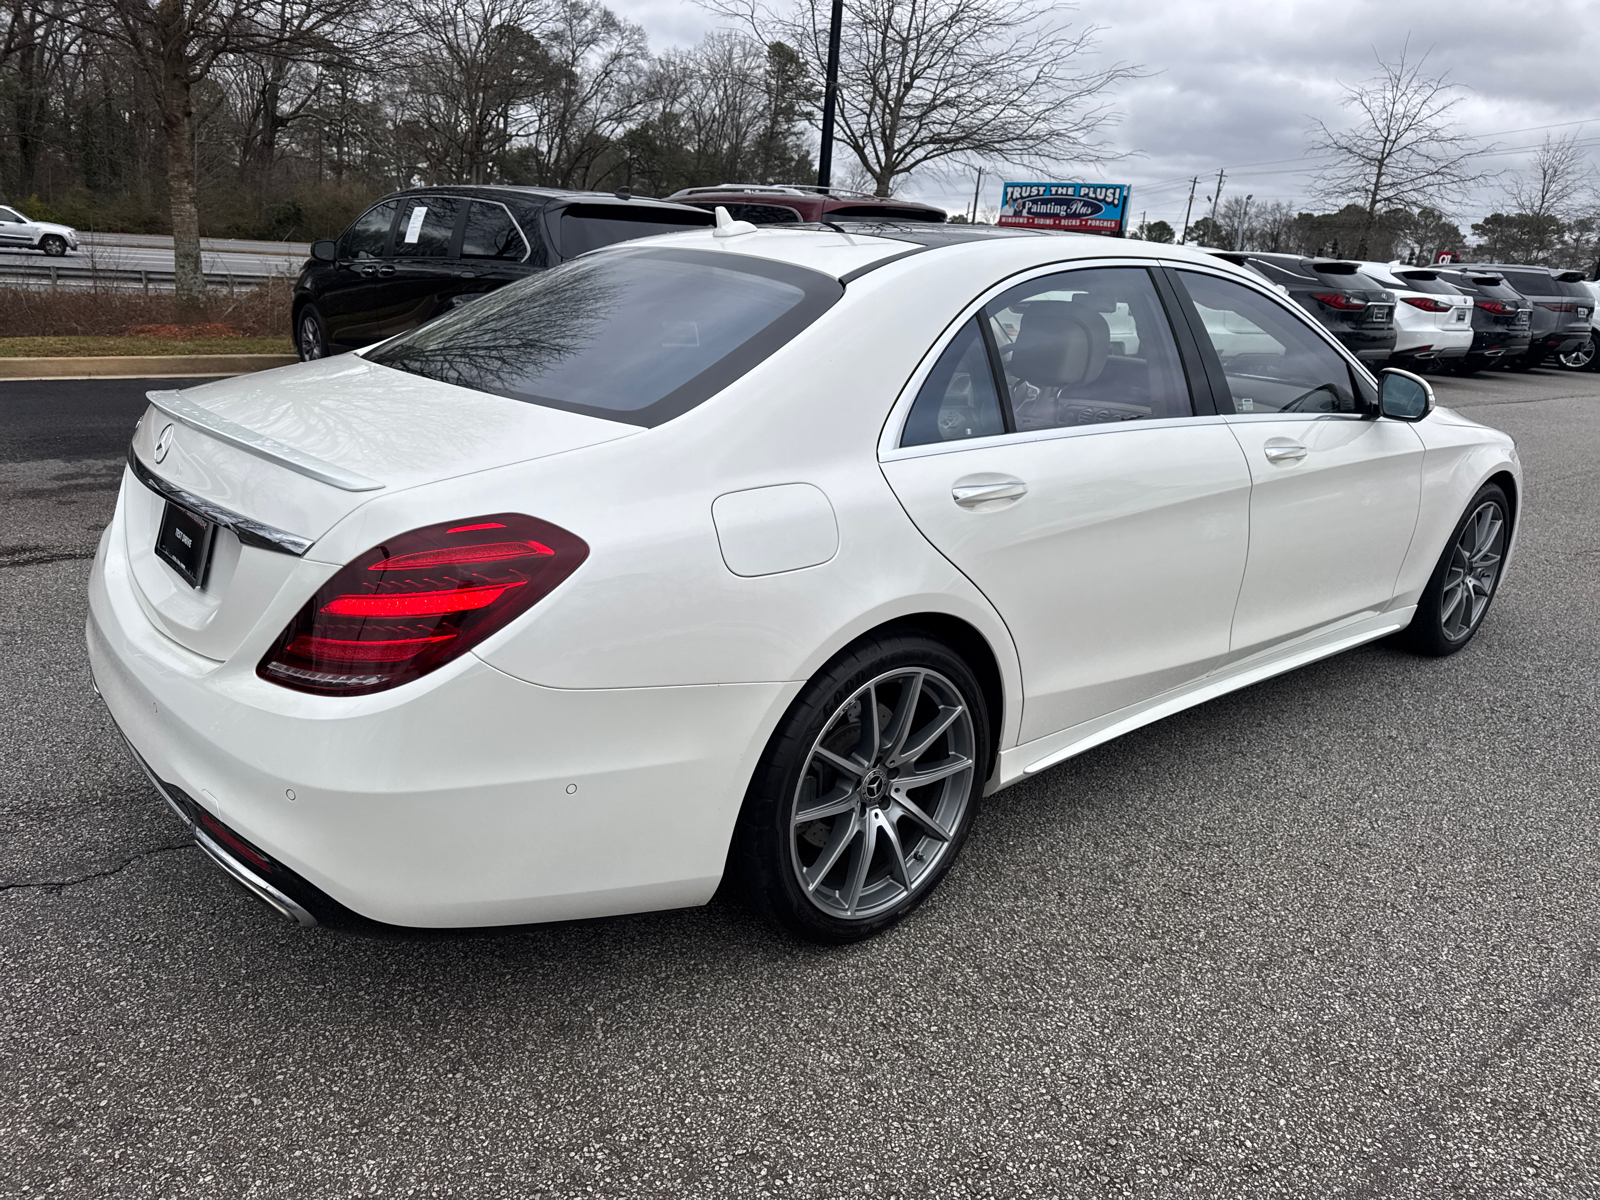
(366, 248, 843, 426)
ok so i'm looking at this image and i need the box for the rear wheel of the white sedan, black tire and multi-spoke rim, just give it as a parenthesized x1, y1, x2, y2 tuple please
(730, 632, 992, 946)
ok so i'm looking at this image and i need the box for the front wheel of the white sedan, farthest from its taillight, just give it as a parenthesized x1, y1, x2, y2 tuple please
(1400, 483, 1510, 658)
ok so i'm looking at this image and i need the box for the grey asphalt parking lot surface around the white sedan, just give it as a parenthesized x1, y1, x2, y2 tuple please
(0, 370, 1600, 1200)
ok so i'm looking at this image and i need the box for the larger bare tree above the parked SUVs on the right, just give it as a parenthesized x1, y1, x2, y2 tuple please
(1310, 46, 1491, 258)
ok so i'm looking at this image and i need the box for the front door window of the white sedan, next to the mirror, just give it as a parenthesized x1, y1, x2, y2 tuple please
(1178, 270, 1362, 413)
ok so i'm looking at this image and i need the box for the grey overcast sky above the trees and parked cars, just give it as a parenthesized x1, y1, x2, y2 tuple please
(608, 0, 1600, 229)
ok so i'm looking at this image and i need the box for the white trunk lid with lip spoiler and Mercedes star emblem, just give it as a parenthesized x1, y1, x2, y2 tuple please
(123, 355, 642, 661)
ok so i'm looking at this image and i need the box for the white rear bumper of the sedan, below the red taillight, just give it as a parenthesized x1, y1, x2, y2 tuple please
(86, 518, 802, 928)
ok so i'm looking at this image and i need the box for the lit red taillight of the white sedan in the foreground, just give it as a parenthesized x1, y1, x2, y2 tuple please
(256, 512, 589, 696)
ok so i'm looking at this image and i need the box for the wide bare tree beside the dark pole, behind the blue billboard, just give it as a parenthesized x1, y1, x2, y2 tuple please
(702, 0, 1138, 195)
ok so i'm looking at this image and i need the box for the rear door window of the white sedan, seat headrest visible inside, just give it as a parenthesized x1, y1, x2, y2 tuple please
(984, 267, 1194, 430)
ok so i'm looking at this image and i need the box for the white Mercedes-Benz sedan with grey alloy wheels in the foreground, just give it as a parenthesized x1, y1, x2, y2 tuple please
(88, 213, 1523, 942)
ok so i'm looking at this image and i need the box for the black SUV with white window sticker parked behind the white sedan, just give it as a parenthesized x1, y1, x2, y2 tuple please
(293, 184, 715, 358)
